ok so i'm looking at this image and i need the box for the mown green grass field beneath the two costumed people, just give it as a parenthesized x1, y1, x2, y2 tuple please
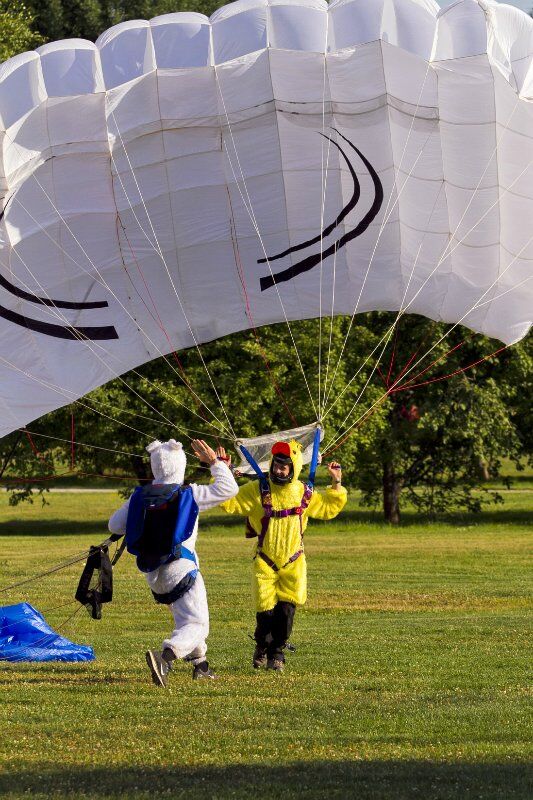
(0, 480, 533, 800)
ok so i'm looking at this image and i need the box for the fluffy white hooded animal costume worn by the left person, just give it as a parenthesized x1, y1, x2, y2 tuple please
(109, 439, 239, 664)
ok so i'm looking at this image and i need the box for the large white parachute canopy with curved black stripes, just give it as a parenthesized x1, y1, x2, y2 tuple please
(0, 0, 533, 435)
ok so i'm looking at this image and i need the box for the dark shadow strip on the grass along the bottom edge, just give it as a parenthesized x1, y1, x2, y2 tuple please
(0, 760, 532, 800)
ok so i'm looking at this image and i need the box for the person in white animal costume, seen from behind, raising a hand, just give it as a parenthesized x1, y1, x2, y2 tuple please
(109, 439, 238, 687)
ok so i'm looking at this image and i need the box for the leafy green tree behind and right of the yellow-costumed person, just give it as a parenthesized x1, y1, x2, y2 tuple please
(344, 317, 531, 523)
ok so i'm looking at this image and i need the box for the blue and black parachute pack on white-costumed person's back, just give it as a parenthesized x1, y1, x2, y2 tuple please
(126, 483, 198, 572)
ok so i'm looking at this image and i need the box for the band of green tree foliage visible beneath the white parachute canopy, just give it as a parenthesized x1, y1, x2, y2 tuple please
(0, 313, 533, 522)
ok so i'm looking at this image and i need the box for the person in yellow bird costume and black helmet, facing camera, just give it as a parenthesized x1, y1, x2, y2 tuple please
(217, 441, 347, 671)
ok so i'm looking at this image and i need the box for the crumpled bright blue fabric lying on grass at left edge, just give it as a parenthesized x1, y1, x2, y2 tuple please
(0, 603, 95, 661)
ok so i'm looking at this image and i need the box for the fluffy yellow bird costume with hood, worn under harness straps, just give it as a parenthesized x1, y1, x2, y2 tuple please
(222, 441, 347, 612)
